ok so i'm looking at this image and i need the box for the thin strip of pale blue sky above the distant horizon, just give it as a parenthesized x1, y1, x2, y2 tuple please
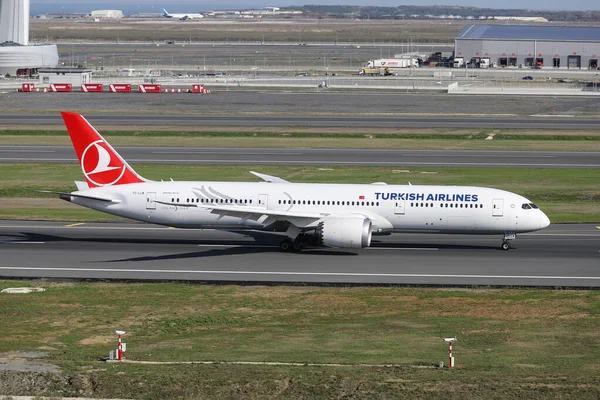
(31, 0, 600, 15)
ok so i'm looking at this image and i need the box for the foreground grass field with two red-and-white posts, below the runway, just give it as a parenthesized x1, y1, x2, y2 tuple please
(0, 281, 600, 399)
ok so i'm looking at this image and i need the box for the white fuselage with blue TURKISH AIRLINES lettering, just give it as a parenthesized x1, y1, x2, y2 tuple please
(70, 181, 550, 234)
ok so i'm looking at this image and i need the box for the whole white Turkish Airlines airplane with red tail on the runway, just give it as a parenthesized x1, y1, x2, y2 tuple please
(44, 112, 550, 252)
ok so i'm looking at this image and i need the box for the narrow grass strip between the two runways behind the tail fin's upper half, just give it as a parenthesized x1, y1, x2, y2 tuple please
(0, 127, 600, 151)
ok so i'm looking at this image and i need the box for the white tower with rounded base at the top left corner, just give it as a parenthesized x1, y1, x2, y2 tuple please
(0, 0, 58, 76)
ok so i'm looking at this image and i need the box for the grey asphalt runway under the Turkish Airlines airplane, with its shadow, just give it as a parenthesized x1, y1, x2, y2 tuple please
(0, 221, 600, 288)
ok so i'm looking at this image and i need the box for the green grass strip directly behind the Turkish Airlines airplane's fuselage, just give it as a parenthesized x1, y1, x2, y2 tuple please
(0, 163, 600, 223)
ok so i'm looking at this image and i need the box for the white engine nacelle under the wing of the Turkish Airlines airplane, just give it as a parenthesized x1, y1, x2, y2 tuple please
(317, 217, 372, 249)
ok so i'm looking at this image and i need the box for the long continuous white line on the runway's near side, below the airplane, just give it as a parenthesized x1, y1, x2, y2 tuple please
(0, 267, 600, 281)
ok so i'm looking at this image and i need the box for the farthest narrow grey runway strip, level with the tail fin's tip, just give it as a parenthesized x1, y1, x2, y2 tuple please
(0, 113, 598, 130)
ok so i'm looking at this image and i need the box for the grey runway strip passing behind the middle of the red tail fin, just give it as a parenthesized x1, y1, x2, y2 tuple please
(0, 145, 600, 168)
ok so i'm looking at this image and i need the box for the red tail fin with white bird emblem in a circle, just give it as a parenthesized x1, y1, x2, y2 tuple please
(61, 112, 145, 188)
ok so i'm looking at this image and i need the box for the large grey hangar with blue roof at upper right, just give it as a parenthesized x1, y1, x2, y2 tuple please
(454, 25, 600, 70)
